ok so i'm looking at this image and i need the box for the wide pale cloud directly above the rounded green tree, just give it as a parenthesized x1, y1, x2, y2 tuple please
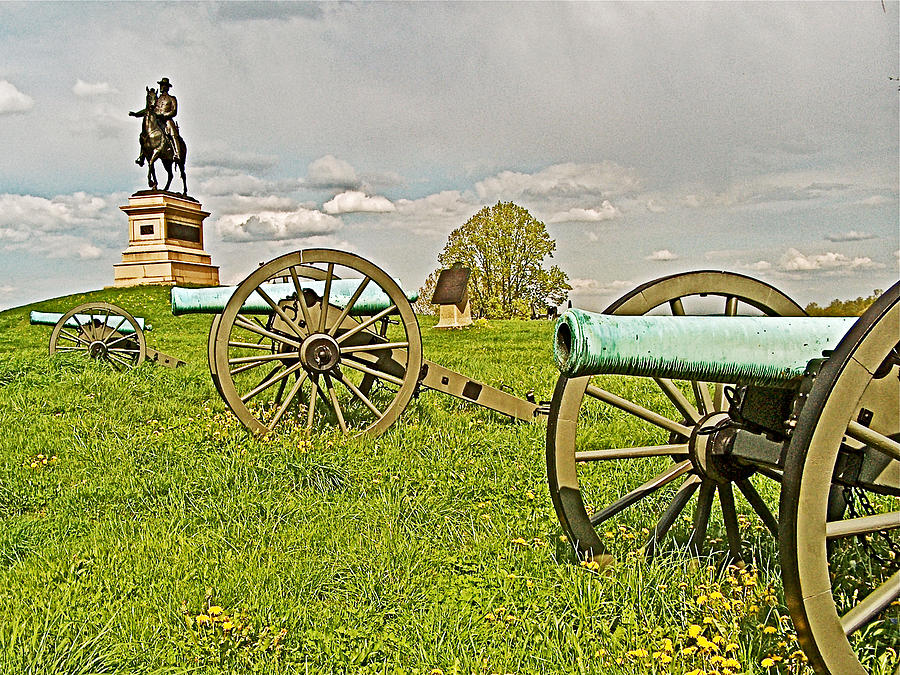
(475, 161, 640, 201)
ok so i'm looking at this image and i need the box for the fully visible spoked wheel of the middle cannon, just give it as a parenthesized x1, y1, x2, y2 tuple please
(210, 249, 422, 435)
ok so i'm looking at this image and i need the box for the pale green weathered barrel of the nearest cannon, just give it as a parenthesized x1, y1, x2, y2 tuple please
(553, 309, 856, 387)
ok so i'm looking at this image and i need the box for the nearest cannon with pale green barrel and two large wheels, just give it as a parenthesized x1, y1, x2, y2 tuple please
(546, 272, 900, 675)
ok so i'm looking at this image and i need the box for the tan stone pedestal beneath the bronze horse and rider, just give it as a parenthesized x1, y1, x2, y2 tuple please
(113, 190, 219, 286)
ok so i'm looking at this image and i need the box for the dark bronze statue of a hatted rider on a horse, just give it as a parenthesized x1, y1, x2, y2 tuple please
(128, 77, 187, 197)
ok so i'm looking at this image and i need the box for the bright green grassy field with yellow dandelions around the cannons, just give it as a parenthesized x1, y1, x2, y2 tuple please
(0, 288, 864, 675)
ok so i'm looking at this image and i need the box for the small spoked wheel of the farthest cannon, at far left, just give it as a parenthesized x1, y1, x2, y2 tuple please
(50, 302, 147, 370)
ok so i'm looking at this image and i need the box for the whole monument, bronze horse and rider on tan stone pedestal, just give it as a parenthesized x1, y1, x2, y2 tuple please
(113, 77, 219, 286)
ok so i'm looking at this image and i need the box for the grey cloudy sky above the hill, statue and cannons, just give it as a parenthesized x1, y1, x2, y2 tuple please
(0, 0, 900, 309)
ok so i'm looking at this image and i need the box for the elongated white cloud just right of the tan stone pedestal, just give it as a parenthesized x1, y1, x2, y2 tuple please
(217, 207, 341, 246)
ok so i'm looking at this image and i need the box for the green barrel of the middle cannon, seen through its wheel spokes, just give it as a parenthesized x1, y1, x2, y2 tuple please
(172, 279, 419, 316)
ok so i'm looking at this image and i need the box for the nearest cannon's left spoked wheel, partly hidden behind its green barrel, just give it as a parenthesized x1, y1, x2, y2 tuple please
(547, 271, 804, 559)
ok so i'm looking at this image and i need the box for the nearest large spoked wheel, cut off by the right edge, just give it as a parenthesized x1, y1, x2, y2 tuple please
(781, 284, 900, 675)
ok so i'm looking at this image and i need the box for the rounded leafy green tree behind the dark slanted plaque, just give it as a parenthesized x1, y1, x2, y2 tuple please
(429, 202, 572, 319)
